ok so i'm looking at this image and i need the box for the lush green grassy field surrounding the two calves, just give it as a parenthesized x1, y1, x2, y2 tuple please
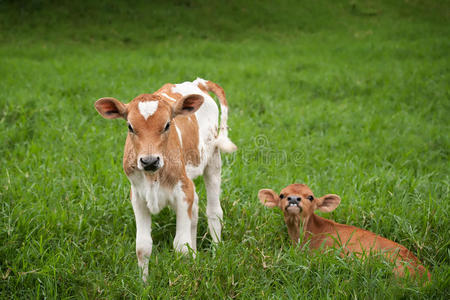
(0, 0, 450, 299)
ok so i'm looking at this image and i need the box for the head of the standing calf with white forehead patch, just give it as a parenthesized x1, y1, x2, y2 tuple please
(95, 94, 203, 172)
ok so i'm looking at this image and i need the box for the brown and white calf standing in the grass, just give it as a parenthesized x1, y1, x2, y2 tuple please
(95, 78, 237, 280)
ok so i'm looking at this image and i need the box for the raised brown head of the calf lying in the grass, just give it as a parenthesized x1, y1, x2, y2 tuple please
(258, 184, 341, 243)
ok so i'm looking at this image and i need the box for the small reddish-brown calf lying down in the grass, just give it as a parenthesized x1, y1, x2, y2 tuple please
(258, 184, 430, 280)
